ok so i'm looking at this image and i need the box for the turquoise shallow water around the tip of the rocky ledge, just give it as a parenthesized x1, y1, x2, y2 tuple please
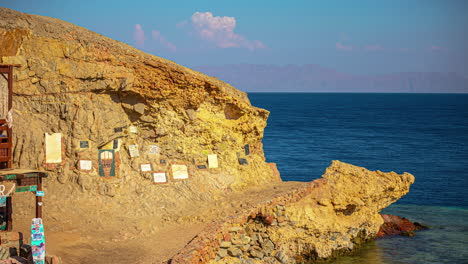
(332, 205, 468, 264)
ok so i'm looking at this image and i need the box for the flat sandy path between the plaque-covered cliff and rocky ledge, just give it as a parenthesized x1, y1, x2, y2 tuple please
(30, 182, 305, 264)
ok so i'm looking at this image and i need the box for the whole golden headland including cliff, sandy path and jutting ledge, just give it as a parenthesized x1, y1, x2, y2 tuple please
(0, 8, 414, 263)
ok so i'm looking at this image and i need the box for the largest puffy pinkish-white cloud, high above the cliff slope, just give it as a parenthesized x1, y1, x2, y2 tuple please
(191, 12, 266, 50)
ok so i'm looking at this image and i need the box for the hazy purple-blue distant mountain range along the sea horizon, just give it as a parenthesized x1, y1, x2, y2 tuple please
(194, 64, 468, 93)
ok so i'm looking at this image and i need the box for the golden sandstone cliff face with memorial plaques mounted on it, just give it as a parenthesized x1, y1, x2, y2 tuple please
(0, 8, 280, 230)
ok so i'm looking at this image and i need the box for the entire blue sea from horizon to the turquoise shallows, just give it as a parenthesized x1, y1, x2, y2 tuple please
(249, 93, 468, 264)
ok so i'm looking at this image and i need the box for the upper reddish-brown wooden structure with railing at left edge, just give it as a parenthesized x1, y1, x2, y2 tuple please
(0, 64, 13, 169)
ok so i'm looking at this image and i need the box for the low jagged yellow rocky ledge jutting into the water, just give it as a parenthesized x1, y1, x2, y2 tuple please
(171, 161, 414, 264)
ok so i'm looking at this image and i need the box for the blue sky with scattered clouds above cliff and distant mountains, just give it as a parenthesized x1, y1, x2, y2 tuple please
(0, 0, 468, 76)
